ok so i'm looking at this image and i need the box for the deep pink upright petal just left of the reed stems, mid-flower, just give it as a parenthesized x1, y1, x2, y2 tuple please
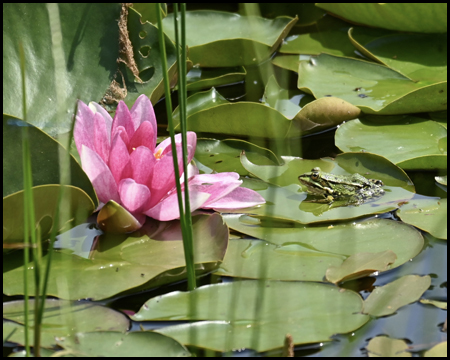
(147, 144, 183, 207)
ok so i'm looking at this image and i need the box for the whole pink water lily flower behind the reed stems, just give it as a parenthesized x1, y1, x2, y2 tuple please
(74, 95, 265, 229)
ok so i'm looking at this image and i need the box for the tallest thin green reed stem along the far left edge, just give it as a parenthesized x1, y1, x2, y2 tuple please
(19, 43, 33, 357)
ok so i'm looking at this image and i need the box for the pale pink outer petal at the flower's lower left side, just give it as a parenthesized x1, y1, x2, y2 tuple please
(80, 145, 120, 204)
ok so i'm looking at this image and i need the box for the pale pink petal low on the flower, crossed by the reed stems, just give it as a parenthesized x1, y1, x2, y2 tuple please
(144, 187, 210, 221)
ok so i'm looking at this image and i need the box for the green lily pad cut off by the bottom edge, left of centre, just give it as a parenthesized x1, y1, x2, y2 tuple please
(58, 331, 191, 357)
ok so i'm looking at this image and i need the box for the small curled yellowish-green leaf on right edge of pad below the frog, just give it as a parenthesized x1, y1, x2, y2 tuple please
(326, 250, 397, 284)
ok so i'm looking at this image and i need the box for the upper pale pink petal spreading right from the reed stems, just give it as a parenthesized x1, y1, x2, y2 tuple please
(189, 172, 242, 208)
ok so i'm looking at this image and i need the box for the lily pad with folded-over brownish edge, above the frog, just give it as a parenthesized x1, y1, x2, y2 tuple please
(263, 76, 361, 136)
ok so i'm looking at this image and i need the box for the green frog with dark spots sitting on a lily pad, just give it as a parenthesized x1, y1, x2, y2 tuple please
(298, 167, 384, 205)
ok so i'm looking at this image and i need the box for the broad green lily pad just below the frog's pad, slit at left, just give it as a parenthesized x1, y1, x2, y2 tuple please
(220, 214, 423, 281)
